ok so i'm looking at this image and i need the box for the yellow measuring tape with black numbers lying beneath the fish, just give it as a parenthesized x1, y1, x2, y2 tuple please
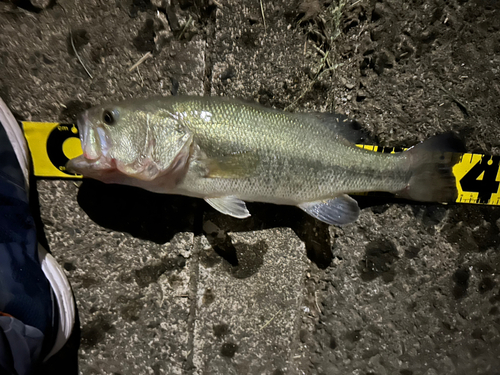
(23, 121, 500, 206)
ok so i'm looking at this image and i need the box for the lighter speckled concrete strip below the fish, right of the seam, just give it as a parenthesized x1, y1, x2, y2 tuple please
(193, 228, 307, 374)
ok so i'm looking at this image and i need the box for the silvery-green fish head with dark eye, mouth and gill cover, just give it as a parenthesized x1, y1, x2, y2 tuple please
(67, 101, 192, 182)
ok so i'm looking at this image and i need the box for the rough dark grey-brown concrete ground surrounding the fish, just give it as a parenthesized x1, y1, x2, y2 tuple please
(0, 0, 500, 375)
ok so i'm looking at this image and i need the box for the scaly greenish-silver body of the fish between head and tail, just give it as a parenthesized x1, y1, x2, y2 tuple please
(166, 100, 408, 204)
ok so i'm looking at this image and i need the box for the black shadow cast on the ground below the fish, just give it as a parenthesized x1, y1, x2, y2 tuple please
(78, 179, 432, 269)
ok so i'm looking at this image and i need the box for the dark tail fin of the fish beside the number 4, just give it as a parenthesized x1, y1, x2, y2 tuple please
(397, 133, 465, 203)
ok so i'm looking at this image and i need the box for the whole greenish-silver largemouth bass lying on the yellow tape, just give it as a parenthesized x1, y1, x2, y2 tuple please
(66, 96, 464, 226)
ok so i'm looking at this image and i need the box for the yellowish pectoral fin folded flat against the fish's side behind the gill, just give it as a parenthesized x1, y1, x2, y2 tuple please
(200, 152, 259, 178)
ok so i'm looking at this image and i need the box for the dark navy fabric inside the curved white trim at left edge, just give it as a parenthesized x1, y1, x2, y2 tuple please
(0, 118, 57, 371)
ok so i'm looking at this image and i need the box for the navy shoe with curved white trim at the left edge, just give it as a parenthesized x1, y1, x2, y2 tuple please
(0, 98, 76, 374)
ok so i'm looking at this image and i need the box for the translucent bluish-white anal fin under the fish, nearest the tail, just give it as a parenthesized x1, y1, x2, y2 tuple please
(299, 194, 359, 225)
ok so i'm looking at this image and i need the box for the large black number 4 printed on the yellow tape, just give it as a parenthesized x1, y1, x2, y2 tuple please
(460, 156, 500, 203)
